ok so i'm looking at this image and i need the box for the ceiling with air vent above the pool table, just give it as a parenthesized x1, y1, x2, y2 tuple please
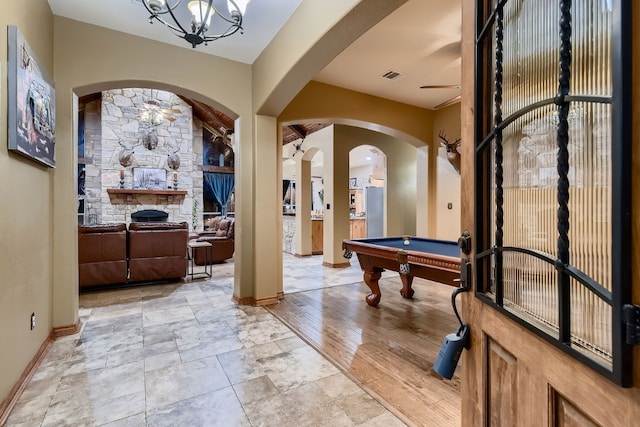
(314, 0, 462, 108)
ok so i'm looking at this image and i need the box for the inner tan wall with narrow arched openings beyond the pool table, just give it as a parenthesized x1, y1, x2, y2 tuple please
(295, 125, 418, 265)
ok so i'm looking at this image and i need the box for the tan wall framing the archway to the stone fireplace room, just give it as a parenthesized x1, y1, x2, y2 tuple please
(53, 17, 253, 316)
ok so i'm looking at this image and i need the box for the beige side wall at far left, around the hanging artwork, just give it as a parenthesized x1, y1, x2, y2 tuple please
(0, 0, 54, 404)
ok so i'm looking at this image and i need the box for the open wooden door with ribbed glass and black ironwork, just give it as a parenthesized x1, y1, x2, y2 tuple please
(459, 0, 640, 426)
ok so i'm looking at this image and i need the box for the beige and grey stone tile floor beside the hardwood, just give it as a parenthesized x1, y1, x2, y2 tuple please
(7, 254, 404, 427)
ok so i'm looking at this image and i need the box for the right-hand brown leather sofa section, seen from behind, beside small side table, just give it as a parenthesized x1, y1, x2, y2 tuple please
(128, 222, 189, 282)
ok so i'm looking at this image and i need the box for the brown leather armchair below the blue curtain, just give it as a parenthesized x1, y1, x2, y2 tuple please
(192, 216, 235, 265)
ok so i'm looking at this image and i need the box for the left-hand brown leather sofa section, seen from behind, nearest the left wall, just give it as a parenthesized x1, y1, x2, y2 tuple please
(78, 224, 127, 288)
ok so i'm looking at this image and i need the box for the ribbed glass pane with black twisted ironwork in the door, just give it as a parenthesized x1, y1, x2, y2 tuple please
(475, 0, 631, 386)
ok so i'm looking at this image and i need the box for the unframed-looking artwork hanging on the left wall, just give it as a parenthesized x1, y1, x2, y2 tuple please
(7, 25, 56, 167)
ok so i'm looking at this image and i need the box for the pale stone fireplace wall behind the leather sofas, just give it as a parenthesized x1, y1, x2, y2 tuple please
(85, 88, 203, 230)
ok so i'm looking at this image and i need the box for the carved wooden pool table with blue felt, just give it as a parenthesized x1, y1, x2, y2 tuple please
(342, 236, 460, 307)
